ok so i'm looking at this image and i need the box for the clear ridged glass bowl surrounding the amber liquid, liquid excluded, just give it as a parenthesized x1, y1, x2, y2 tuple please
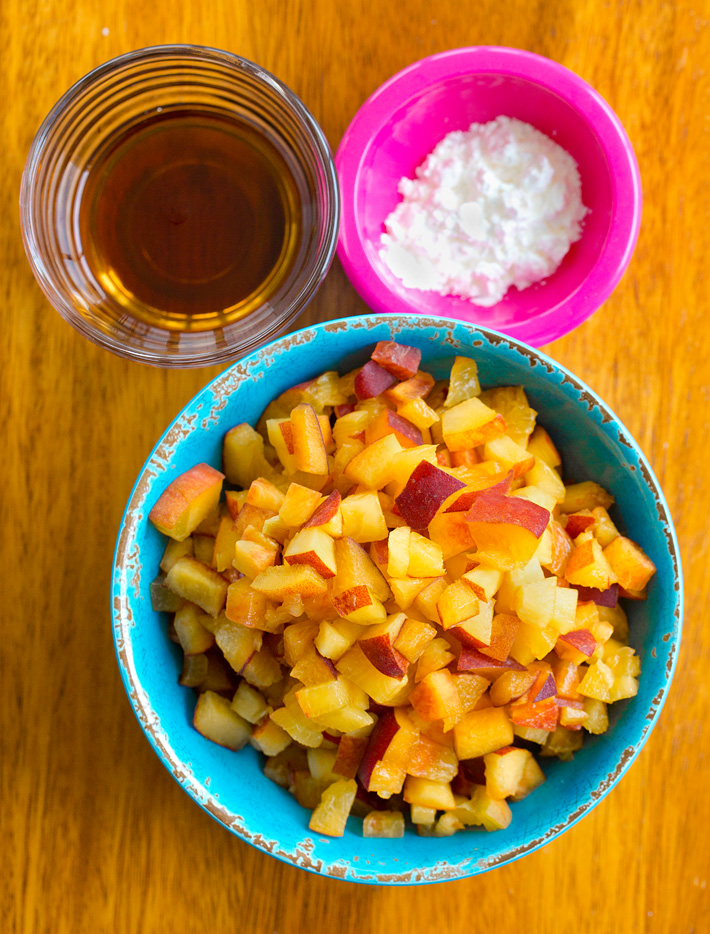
(20, 45, 339, 367)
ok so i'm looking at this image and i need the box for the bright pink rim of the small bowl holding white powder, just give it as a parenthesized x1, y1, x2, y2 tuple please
(335, 46, 642, 347)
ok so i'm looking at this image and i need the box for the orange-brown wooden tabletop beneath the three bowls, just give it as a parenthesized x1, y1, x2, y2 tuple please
(0, 0, 710, 934)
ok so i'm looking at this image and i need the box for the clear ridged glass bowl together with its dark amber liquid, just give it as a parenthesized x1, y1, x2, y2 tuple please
(20, 46, 339, 366)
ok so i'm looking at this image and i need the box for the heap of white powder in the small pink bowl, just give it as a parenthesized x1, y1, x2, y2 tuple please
(381, 117, 587, 306)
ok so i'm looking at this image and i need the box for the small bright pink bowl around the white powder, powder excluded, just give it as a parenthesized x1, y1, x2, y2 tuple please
(335, 46, 641, 347)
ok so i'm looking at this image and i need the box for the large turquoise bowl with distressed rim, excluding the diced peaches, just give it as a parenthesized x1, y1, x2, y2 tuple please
(112, 315, 683, 885)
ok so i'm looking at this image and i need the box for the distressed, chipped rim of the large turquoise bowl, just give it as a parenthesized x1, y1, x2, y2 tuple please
(111, 314, 683, 885)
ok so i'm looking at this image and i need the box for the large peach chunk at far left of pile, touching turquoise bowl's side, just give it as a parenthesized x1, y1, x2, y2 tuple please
(148, 464, 224, 541)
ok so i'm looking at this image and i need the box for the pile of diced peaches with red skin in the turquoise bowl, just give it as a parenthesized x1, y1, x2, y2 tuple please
(150, 341, 655, 837)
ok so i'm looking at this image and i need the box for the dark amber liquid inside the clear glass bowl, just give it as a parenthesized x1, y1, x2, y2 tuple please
(79, 111, 300, 331)
